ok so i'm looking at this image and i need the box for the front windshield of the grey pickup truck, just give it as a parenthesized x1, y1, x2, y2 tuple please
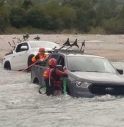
(67, 56, 116, 73)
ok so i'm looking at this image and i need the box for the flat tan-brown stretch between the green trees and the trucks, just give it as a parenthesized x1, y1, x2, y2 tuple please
(0, 34, 124, 61)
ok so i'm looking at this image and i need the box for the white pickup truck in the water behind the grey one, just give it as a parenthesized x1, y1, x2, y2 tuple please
(3, 41, 60, 70)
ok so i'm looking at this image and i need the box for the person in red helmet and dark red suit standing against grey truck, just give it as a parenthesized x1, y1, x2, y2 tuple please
(43, 58, 67, 96)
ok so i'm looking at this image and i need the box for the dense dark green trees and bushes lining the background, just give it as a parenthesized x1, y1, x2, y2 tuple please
(0, 0, 124, 34)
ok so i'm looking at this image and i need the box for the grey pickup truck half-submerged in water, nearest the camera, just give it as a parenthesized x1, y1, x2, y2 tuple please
(31, 40, 124, 97)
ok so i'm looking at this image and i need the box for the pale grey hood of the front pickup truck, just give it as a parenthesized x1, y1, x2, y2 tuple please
(71, 72, 124, 83)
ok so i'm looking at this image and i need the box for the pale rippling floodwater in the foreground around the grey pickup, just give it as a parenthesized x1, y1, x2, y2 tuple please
(0, 63, 124, 127)
